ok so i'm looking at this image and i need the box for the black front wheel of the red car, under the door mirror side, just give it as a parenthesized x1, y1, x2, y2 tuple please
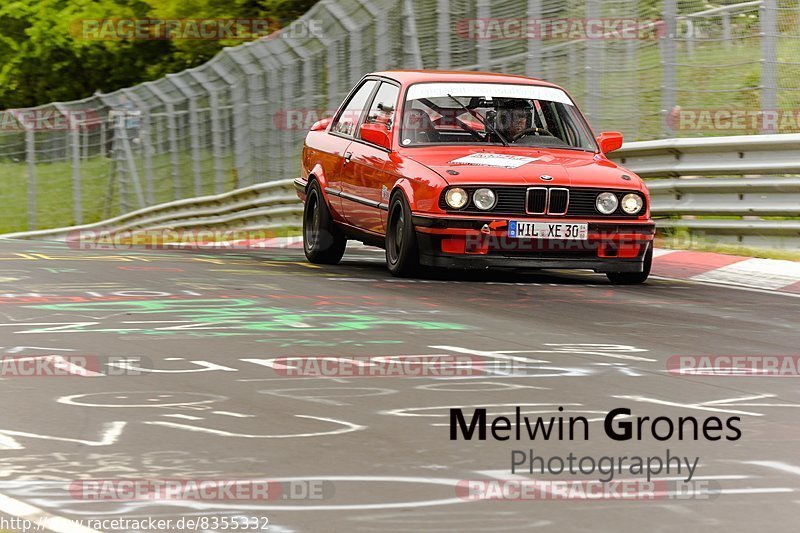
(386, 191, 419, 278)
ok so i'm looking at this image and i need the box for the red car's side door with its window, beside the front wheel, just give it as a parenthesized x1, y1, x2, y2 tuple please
(342, 81, 400, 234)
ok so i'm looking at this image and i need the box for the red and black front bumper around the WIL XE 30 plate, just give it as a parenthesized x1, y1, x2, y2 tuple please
(413, 215, 655, 272)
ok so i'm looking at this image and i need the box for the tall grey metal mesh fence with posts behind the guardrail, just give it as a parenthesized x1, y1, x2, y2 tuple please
(0, 0, 800, 232)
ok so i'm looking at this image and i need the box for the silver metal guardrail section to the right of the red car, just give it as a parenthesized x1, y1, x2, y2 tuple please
(611, 134, 800, 248)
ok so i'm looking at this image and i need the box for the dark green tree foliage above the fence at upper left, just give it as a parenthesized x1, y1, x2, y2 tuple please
(0, 0, 316, 109)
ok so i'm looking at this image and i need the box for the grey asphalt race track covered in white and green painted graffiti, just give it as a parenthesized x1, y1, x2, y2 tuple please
(0, 241, 800, 532)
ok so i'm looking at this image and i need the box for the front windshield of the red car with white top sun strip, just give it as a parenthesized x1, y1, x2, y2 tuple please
(400, 83, 596, 152)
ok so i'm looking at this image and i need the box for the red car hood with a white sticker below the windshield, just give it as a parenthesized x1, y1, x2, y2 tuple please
(404, 146, 642, 190)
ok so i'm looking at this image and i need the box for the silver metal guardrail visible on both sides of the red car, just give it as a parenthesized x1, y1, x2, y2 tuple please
(5, 134, 800, 248)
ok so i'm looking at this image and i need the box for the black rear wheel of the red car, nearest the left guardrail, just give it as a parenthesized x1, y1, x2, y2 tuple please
(303, 180, 347, 265)
